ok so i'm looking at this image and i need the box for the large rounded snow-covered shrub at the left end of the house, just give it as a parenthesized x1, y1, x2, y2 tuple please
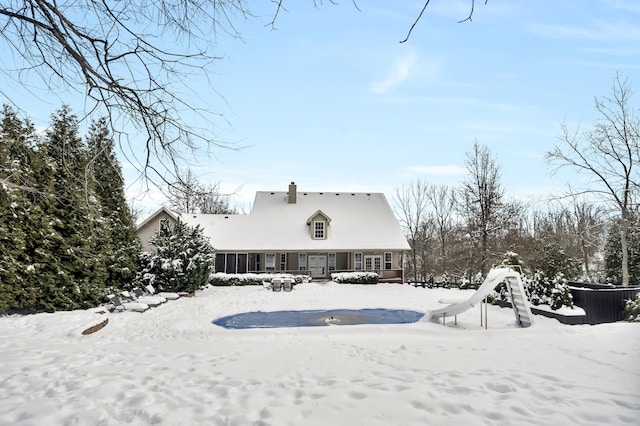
(136, 221, 214, 293)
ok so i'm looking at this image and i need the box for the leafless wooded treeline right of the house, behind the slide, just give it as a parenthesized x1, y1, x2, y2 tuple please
(394, 149, 640, 285)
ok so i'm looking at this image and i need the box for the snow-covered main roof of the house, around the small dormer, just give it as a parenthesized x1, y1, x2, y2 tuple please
(180, 191, 410, 252)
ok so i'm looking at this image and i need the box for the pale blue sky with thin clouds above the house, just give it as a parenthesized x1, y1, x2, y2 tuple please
(1, 0, 640, 213)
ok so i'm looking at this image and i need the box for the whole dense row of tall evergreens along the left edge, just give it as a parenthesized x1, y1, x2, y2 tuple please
(0, 107, 139, 312)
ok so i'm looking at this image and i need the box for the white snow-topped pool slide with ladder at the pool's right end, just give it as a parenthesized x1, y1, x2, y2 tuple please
(428, 268, 533, 327)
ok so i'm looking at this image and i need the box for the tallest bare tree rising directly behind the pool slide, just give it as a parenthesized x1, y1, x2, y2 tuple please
(458, 142, 504, 275)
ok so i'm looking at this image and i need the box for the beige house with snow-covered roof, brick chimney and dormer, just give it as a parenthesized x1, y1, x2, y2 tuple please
(138, 182, 410, 282)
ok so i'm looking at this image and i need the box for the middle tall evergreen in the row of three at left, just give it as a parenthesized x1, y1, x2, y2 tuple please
(41, 106, 106, 309)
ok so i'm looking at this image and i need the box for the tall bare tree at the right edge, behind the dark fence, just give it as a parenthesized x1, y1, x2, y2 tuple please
(546, 74, 640, 287)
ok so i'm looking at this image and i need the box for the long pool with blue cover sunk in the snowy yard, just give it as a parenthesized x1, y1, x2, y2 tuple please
(212, 309, 424, 329)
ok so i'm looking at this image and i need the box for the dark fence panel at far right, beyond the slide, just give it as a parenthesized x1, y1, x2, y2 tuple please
(569, 282, 640, 324)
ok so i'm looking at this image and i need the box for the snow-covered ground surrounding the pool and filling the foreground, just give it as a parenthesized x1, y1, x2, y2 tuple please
(0, 283, 640, 425)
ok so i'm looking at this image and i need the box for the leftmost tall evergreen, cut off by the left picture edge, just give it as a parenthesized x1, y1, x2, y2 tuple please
(0, 106, 62, 312)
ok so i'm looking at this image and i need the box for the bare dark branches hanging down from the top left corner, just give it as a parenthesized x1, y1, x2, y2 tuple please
(0, 0, 250, 187)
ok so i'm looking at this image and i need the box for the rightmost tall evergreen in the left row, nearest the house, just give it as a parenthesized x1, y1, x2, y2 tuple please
(87, 118, 141, 288)
